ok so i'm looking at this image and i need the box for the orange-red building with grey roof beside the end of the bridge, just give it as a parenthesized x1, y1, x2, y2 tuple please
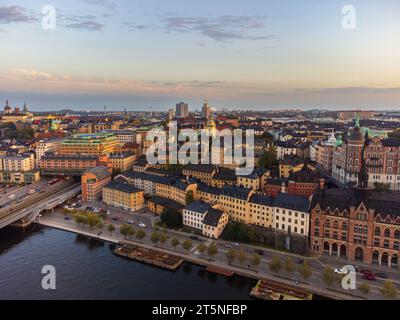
(81, 167, 111, 201)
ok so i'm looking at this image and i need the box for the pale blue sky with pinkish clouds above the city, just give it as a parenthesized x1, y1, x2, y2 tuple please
(0, 0, 400, 110)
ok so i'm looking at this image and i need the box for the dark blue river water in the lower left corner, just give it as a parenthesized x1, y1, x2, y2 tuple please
(0, 226, 256, 300)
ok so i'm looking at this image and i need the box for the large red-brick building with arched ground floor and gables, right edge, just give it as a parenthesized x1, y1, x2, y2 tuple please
(310, 188, 400, 268)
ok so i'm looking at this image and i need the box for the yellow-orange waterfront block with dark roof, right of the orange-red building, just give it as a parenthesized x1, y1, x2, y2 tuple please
(103, 179, 145, 212)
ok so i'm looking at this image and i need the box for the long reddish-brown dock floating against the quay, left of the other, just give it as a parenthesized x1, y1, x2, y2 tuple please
(113, 244, 183, 271)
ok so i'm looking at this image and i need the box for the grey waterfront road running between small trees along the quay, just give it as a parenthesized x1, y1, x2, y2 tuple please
(41, 203, 400, 299)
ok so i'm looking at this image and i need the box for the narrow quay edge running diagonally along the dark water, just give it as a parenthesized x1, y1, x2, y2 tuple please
(35, 221, 362, 300)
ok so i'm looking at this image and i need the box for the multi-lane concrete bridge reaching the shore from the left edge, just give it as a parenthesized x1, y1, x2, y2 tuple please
(0, 183, 81, 229)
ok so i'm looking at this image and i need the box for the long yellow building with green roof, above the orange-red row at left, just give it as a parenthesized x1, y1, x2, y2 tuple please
(60, 133, 119, 156)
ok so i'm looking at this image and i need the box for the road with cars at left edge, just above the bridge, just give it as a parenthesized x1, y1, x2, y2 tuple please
(0, 179, 48, 209)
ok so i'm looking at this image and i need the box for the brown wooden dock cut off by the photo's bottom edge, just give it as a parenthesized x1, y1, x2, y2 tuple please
(250, 280, 313, 300)
